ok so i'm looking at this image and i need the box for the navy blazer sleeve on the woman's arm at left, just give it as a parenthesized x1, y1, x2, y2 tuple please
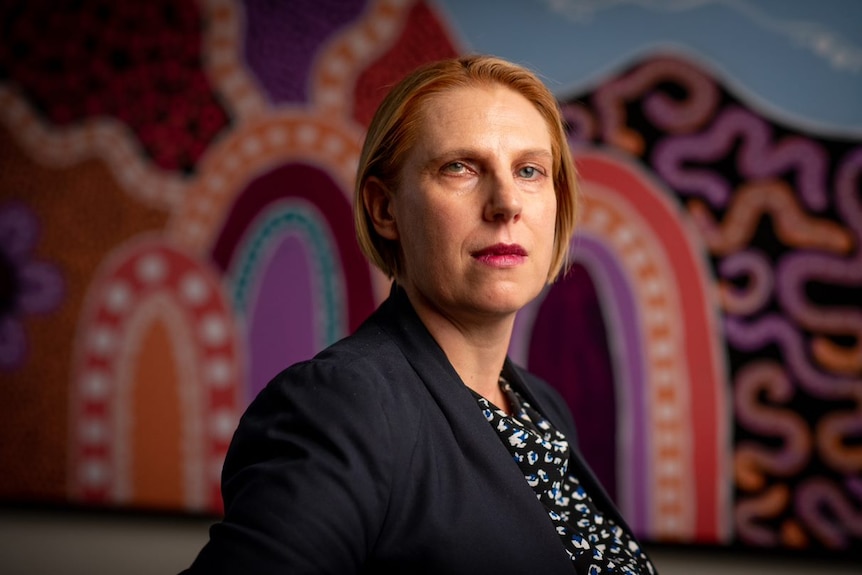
(187, 361, 393, 575)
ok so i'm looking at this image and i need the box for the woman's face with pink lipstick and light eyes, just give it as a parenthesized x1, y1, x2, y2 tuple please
(390, 86, 557, 322)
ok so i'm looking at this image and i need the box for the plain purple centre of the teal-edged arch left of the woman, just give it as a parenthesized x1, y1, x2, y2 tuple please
(248, 236, 318, 399)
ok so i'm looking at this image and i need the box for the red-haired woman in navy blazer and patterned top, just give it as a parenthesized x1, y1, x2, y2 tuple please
(181, 56, 654, 575)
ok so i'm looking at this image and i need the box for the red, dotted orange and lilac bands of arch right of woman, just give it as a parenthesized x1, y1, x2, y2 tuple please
(515, 152, 731, 542)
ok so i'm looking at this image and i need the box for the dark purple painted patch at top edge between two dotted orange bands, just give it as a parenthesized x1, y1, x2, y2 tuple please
(245, 0, 365, 104)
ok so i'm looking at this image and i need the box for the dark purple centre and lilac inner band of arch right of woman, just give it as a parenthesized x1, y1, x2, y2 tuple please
(528, 235, 650, 534)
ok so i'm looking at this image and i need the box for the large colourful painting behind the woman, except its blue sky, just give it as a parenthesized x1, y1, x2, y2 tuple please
(0, 0, 862, 554)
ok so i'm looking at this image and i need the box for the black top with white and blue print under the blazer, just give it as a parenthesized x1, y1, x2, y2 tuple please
(474, 379, 655, 575)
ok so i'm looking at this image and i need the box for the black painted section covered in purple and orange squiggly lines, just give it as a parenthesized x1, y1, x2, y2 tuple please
(580, 58, 862, 549)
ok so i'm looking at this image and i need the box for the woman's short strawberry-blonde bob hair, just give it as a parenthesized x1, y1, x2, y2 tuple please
(353, 55, 578, 283)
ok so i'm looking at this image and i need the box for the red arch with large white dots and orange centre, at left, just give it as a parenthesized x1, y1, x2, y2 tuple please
(69, 237, 244, 512)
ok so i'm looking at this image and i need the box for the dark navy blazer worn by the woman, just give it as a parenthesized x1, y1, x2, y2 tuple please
(187, 288, 640, 575)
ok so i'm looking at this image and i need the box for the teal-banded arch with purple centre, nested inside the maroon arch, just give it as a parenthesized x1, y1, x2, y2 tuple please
(226, 197, 347, 399)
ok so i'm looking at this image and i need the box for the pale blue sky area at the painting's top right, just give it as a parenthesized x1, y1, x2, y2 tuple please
(433, 0, 862, 137)
